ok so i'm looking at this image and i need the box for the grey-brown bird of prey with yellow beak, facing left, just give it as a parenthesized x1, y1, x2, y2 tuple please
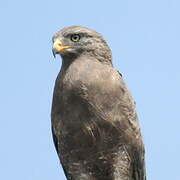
(51, 26, 146, 180)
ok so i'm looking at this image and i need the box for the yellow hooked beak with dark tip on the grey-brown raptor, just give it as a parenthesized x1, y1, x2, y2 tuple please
(52, 39, 72, 58)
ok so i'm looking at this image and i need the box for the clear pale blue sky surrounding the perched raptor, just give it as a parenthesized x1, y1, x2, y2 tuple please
(0, 0, 180, 180)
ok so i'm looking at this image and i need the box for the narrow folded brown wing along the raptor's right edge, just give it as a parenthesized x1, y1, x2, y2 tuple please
(115, 72, 146, 180)
